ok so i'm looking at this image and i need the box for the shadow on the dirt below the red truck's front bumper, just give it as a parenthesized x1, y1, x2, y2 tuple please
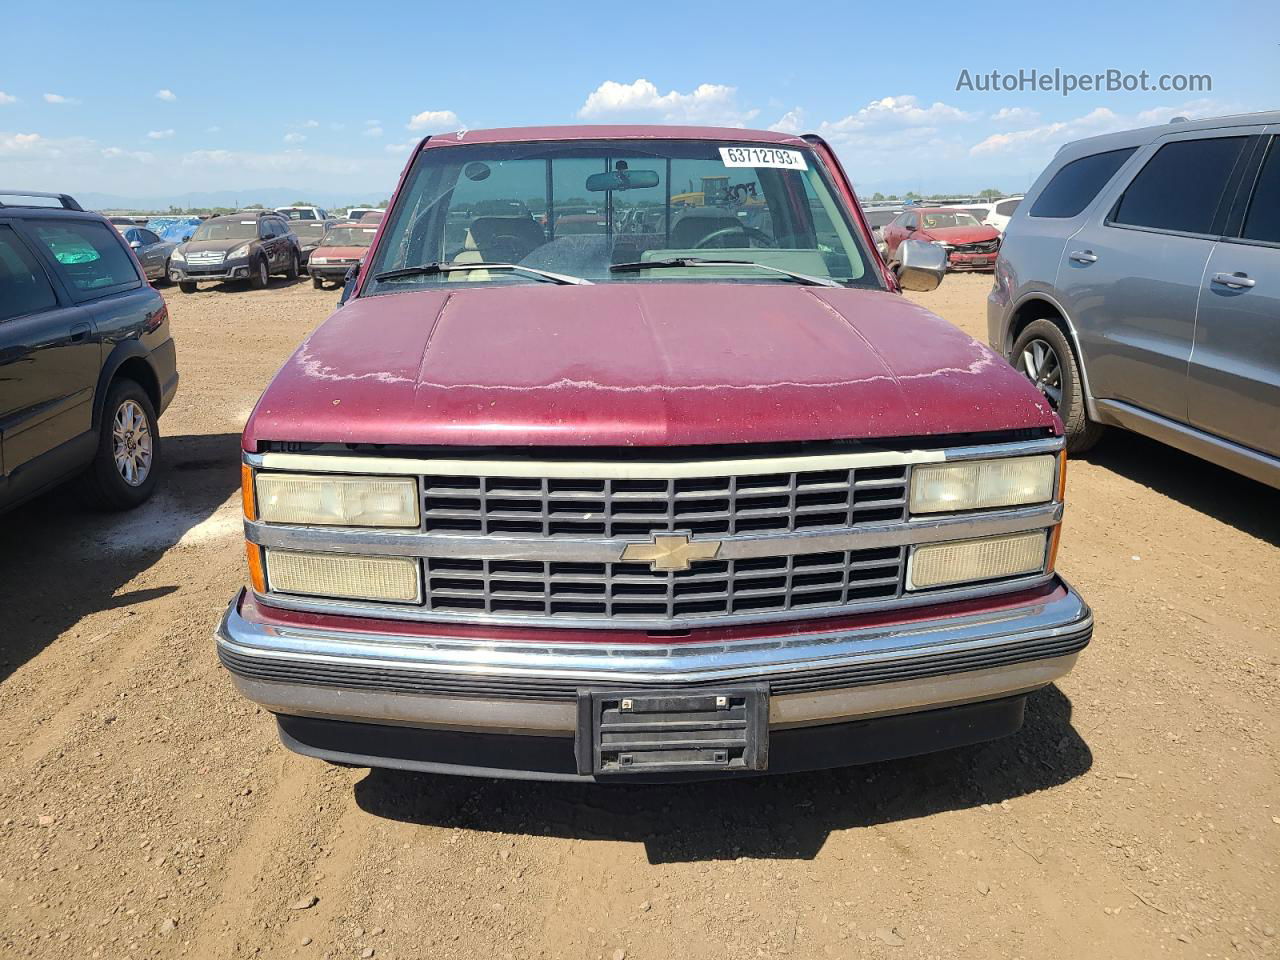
(356, 686, 1093, 863)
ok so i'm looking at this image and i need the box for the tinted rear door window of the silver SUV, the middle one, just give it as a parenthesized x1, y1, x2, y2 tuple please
(1111, 137, 1248, 233)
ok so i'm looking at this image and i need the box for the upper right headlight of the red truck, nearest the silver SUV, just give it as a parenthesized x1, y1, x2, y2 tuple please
(910, 453, 1057, 513)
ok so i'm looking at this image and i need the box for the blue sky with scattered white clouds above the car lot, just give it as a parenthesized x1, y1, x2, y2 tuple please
(0, 0, 1280, 202)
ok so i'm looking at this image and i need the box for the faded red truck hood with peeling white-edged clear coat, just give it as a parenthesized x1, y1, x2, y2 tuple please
(243, 280, 1059, 452)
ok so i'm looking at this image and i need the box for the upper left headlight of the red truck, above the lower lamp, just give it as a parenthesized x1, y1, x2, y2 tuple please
(257, 474, 419, 526)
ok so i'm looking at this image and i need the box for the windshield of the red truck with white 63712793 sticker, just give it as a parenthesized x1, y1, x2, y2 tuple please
(366, 140, 879, 293)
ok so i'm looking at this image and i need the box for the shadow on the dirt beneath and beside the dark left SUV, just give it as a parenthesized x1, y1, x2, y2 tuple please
(0, 432, 241, 681)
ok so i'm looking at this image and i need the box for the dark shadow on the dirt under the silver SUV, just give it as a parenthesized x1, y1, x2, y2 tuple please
(1068, 430, 1280, 545)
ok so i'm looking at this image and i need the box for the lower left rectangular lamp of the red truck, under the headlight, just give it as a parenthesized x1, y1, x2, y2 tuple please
(266, 550, 422, 603)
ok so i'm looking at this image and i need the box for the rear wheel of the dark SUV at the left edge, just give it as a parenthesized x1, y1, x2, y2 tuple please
(84, 380, 160, 509)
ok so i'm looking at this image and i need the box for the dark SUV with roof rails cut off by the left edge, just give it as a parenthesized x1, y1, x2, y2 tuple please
(0, 191, 178, 511)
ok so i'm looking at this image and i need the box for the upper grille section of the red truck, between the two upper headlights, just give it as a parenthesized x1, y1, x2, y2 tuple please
(422, 466, 906, 538)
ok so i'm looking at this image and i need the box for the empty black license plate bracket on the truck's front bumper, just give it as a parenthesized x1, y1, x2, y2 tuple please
(575, 684, 769, 777)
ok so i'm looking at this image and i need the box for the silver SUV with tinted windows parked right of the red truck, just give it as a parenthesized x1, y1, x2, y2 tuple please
(987, 111, 1280, 486)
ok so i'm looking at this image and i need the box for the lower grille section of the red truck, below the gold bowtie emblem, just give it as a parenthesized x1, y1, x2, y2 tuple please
(425, 547, 905, 623)
